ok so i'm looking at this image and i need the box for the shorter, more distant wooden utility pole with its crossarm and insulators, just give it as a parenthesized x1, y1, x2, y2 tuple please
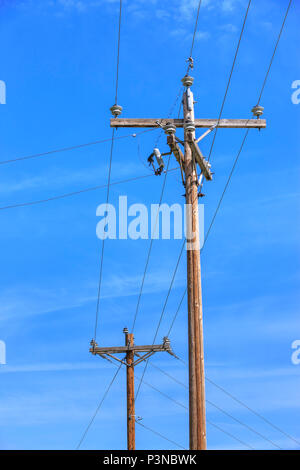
(90, 328, 175, 450)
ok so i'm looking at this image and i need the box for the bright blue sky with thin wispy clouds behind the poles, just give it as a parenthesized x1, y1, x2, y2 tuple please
(0, 0, 300, 449)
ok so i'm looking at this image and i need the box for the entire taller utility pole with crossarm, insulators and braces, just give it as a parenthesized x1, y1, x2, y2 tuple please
(111, 75, 266, 450)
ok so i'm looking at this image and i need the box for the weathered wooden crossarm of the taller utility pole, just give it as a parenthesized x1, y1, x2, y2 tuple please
(110, 118, 267, 129)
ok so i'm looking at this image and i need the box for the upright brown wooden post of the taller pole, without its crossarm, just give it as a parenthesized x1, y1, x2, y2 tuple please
(183, 77, 206, 450)
